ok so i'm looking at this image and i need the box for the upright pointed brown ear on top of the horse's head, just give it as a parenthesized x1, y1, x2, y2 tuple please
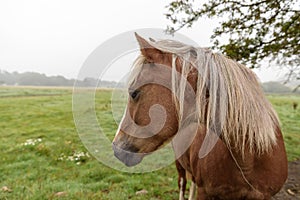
(135, 33, 163, 62)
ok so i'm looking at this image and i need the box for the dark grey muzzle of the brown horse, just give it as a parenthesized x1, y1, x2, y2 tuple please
(112, 144, 144, 167)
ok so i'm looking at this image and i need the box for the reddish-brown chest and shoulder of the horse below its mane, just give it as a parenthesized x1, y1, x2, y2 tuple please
(178, 126, 287, 200)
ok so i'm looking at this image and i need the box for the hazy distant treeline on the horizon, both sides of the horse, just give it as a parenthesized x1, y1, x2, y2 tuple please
(0, 70, 300, 94)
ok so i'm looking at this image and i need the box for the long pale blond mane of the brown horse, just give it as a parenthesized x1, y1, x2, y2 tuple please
(130, 40, 279, 154)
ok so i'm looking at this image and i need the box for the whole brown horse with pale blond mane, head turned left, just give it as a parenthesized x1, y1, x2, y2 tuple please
(113, 35, 287, 200)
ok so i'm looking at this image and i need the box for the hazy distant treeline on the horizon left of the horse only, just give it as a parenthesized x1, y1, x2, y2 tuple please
(0, 70, 117, 88)
